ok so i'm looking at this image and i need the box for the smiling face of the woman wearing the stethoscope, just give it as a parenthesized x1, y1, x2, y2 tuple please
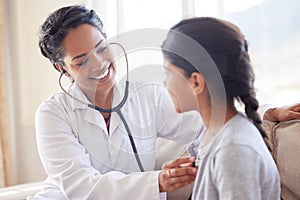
(62, 24, 115, 98)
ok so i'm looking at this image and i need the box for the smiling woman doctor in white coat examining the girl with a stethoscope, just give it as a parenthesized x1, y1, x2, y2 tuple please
(28, 6, 202, 200)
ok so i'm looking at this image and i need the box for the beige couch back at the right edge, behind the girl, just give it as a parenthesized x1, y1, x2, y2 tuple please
(263, 120, 300, 200)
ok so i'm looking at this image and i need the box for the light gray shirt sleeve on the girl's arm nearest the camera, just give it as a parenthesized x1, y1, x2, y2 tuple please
(211, 145, 262, 200)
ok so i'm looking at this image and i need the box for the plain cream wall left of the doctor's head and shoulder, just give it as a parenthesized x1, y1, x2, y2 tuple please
(4, 0, 98, 184)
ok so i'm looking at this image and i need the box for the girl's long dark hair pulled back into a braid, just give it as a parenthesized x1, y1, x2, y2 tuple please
(162, 17, 268, 145)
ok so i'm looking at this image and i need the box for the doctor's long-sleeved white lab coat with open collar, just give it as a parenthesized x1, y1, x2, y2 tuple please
(29, 81, 203, 200)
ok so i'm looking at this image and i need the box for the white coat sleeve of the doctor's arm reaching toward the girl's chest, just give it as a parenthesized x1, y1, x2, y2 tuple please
(35, 102, 161, 200)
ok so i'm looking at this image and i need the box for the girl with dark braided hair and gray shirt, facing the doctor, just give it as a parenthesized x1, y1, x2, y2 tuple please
(162, 18, 280, 200)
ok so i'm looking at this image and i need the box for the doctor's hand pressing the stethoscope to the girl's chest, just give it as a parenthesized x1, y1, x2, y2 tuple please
(158, 157, 197, 192)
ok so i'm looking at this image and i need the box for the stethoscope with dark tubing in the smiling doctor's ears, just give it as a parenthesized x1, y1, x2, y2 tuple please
(58, 42, 145, 172)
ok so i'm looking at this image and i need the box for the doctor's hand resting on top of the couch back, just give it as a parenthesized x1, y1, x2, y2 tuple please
(263, 103, 300, 122)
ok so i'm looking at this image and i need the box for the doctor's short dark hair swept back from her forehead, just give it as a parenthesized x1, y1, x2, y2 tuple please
(39, 5, 106, 69)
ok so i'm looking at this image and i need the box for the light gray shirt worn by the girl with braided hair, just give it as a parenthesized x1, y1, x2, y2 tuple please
(192, 114, 280, 200)
